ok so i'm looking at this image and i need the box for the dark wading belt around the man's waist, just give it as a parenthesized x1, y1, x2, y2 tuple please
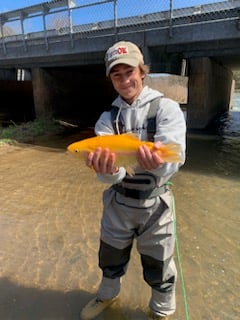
(112, 184, 169, 199)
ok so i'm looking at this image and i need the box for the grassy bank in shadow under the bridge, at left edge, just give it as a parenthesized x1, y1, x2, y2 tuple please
(0, 117, 63, 145)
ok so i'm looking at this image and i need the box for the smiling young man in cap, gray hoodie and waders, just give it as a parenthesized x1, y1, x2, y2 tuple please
(80, 41, 186, 320)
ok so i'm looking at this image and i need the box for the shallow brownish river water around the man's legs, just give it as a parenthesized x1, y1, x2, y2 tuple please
(0, 112, 240, 320)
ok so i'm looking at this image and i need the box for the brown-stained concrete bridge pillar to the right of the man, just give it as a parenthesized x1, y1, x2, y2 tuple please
(187, 58, 233, 129)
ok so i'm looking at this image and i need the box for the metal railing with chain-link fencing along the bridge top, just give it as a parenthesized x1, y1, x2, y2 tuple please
(0, 0, 240, 54)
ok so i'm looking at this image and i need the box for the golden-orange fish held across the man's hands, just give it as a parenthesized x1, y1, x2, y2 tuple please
(67, 133, 182, 175)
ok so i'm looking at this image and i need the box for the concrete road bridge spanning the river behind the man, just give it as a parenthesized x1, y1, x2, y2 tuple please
(0, 0, 240, 129)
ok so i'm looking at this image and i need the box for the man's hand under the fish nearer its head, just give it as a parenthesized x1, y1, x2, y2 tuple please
(86, 147, 118, 174)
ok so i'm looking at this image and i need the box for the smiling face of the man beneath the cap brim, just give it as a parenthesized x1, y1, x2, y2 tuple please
(110, 64, 144, 104)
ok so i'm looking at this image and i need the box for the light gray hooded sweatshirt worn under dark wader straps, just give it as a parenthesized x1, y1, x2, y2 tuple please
(95, 86, 186, 190)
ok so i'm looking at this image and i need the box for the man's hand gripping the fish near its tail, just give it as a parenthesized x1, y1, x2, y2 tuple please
(137, 141, 164, 170)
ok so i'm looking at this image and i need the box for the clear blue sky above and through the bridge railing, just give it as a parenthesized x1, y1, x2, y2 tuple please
(0, 0, 224, 33)
